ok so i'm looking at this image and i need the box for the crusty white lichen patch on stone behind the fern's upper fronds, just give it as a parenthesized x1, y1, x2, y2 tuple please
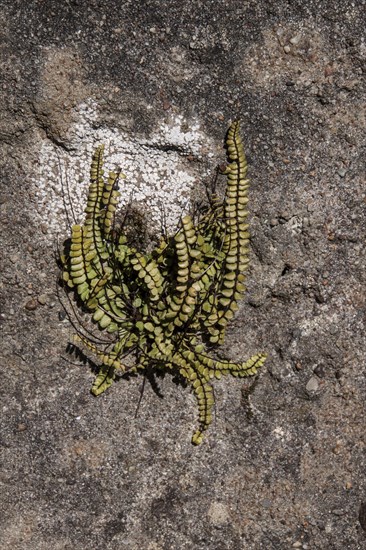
(34, 101, 212, 239)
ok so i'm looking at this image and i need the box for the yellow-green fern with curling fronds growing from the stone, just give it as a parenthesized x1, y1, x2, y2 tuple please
(62, 121, 266, 445)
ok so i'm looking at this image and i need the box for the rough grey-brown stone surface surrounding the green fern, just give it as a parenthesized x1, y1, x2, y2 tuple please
(0, 0, 366, 550)
